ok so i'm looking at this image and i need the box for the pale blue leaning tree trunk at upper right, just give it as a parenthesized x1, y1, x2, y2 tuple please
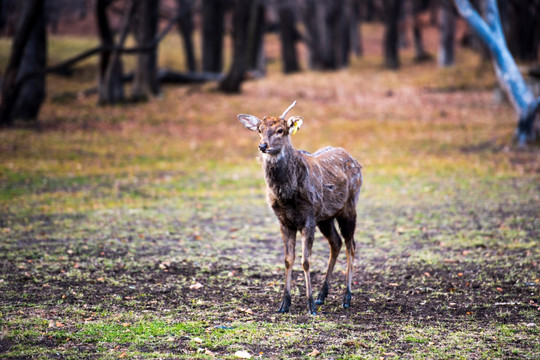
(454, 0, 540, 145)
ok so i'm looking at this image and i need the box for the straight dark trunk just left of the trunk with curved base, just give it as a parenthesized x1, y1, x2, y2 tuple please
(202, 0, 226, 72)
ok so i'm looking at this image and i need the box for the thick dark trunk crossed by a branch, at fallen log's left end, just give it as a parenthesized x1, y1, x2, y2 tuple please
(132, 0, 159, 101)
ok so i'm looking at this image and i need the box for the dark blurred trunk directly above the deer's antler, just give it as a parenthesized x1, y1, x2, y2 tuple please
(278, 0, 300, 74)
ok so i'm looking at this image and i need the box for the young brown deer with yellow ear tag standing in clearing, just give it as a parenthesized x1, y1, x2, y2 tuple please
(238, 101, 362, 315)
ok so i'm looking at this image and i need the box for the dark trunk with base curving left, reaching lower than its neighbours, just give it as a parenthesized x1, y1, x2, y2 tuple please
(219, 0, 251, 93)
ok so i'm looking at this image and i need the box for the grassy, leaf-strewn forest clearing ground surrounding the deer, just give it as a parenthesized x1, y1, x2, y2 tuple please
(0, 23, 540, 359)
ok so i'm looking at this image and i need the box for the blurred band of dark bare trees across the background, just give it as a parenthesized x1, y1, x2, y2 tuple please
(0, 0, 540, 131)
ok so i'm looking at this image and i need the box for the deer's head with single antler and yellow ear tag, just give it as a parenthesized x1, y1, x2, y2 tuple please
(238, 101, 304, 155)
